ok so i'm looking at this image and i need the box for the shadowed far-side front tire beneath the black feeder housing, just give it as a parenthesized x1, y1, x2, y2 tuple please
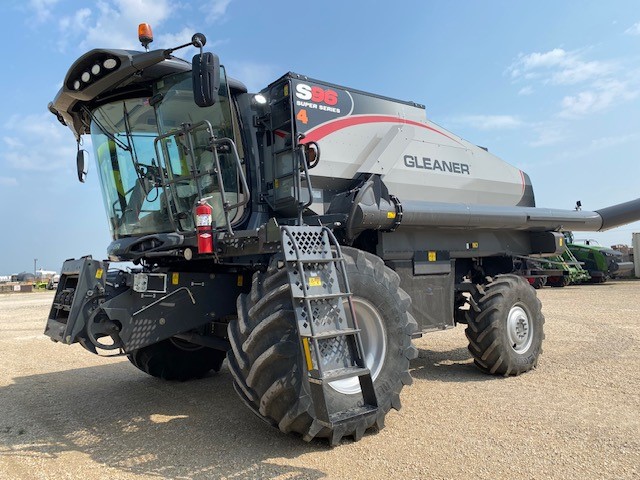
(127, 338, 226, 382)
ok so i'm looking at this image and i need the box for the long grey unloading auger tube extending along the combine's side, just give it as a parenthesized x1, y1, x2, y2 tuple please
(350, 194, 640, 232)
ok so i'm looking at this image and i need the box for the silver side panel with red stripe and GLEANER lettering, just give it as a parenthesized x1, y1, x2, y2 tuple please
(280, 74, 534, 206)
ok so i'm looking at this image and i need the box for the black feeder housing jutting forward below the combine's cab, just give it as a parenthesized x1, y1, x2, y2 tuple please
(45, 257, 251, 353)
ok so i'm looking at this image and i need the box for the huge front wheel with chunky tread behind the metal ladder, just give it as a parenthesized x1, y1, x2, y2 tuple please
(228, 247, 417, 445)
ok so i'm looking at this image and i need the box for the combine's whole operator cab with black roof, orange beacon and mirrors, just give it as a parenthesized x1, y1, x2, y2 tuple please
(49, 30, 249, 259)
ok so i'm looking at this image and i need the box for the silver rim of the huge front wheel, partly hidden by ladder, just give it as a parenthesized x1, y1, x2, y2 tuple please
(329, 296, 387, 395)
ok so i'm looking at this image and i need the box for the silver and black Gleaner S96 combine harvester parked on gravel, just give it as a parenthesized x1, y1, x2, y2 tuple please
(46, 26, 640, 444)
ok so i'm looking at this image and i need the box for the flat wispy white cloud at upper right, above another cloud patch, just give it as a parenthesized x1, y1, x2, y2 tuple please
(507, 48, 617, 85)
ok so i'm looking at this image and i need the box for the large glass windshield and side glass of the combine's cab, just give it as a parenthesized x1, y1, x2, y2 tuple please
(91, 67, 239, 239)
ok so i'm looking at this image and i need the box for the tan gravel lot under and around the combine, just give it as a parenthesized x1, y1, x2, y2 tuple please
(0, 281, 640, 479)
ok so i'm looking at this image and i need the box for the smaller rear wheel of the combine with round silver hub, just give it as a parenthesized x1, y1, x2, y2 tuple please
(465, 275, 544, 376)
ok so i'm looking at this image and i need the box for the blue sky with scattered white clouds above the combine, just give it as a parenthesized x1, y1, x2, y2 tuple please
(0, 0, 640, 275)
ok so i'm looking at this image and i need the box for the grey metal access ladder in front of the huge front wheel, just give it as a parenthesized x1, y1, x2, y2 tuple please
(281, 226, 378, 428)
